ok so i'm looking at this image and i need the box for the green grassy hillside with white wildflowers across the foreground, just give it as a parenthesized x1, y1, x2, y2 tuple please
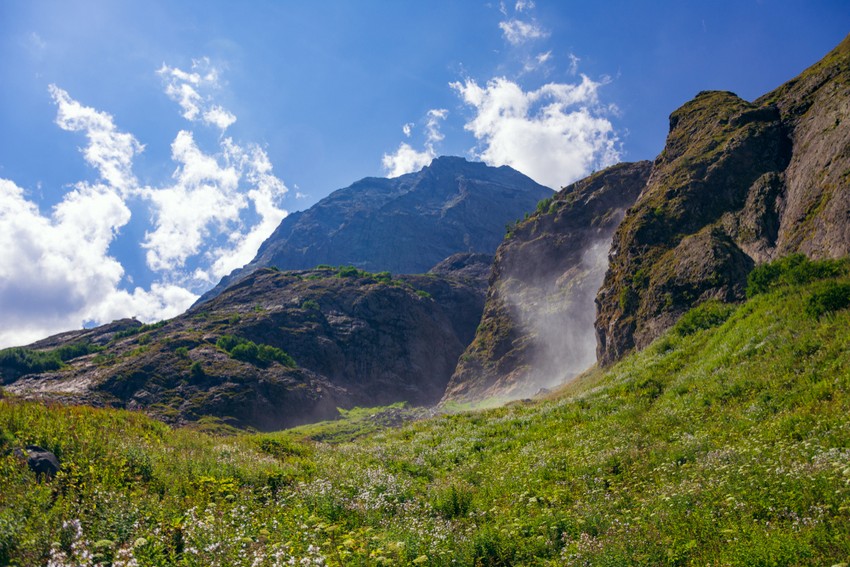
(0, 261, 850, 566)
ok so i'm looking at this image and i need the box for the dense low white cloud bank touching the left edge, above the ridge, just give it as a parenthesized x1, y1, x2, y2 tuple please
(0, 175, 197, 347)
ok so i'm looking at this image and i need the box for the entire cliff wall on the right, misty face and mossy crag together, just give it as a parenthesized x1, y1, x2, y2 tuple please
(444, 35, 850, 401)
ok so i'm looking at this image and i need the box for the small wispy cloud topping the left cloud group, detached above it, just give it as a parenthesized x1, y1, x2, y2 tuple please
(157, 57, 236, 132)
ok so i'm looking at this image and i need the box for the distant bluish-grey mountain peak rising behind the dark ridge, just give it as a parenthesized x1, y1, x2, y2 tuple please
(198, 157, 552, 303)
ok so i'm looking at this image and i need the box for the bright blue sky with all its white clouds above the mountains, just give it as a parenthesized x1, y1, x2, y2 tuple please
(0, 0, 850, 346)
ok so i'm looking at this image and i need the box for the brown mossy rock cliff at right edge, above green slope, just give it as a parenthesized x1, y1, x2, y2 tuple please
(596, 34, 850, 364)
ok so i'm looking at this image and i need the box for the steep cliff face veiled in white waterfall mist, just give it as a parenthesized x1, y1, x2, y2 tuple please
(444, 162, 652, 401)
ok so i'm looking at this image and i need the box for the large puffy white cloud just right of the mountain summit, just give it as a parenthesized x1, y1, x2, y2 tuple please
(450, 76, 620, 188)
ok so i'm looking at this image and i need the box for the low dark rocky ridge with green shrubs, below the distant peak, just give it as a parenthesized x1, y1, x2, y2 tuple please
(0, 266, 489, 430)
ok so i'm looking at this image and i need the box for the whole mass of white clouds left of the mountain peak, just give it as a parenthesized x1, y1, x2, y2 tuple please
(0, 66, 287, 348)
